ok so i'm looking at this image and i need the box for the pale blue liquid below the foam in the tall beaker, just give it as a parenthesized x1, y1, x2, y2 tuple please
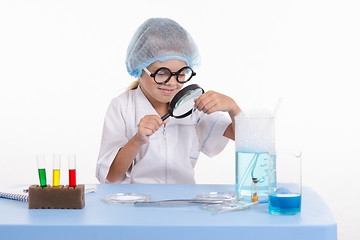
(235, 151, 268, 198)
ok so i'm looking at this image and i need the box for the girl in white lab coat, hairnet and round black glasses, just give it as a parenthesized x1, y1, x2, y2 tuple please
(96, 18, 241, 183)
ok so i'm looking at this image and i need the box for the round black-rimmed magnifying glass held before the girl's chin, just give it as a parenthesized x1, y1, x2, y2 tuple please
(161, 84, 204, 121)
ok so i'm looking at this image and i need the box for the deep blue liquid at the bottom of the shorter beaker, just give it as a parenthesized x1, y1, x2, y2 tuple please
(269, 193, 301, 215)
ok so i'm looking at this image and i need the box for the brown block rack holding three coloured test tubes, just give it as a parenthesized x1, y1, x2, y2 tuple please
(29, 184, 85, 209)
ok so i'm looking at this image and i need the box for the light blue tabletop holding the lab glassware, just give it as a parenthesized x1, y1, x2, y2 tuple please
(0, 184, 337, 240)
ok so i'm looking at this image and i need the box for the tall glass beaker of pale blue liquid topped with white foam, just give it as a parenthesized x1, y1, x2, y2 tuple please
(235, 112, 275, 199)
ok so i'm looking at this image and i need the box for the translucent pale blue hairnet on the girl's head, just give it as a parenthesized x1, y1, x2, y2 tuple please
(126, 18, 199, 77)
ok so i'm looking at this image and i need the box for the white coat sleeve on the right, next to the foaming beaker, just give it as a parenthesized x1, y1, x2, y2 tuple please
(196, 112, 231, 157)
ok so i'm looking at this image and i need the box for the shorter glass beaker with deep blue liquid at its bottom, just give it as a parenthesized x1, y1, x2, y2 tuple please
(269, 150, 302, 215)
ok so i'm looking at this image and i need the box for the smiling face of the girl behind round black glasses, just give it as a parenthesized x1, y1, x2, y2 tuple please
(140, 59, 187, 107)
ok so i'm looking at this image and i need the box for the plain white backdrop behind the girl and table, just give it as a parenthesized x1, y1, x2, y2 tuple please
(0, 0, 360, 239)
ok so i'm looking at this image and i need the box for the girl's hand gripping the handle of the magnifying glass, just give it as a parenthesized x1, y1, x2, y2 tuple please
(135, 115, 168, 145)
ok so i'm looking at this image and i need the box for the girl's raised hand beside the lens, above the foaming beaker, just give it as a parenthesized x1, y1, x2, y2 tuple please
(195, 91, 241, 118)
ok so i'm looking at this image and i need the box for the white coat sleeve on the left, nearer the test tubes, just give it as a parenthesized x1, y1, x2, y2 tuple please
(96, 98, 129, 183)
